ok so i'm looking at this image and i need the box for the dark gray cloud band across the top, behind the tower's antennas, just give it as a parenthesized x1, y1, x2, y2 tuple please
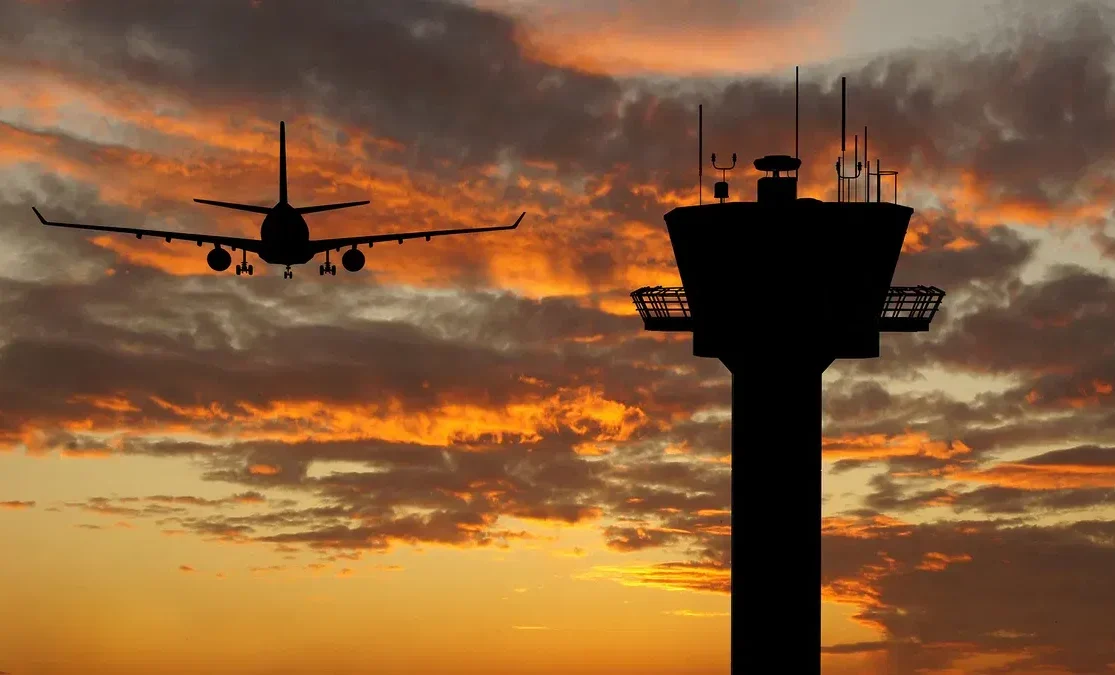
(0, 0, 1115, 206)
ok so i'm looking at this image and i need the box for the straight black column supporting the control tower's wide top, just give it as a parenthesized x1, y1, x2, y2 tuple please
(721, 355, 822, 674)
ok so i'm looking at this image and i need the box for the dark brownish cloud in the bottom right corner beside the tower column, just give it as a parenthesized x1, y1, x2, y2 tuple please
(822, 521, 1115, 673)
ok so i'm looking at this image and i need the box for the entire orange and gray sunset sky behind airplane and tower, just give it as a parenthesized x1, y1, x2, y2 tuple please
(0, 0, 1115, 675)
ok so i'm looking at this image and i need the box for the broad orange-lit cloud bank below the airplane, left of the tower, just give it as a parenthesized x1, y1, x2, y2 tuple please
(0, 254, 729, 562)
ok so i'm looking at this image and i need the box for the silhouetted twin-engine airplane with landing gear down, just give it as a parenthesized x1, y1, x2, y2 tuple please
(31, 122, 526, 279)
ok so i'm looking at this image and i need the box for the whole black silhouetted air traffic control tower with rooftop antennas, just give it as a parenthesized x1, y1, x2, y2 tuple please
(631, 71, 944, 675)
